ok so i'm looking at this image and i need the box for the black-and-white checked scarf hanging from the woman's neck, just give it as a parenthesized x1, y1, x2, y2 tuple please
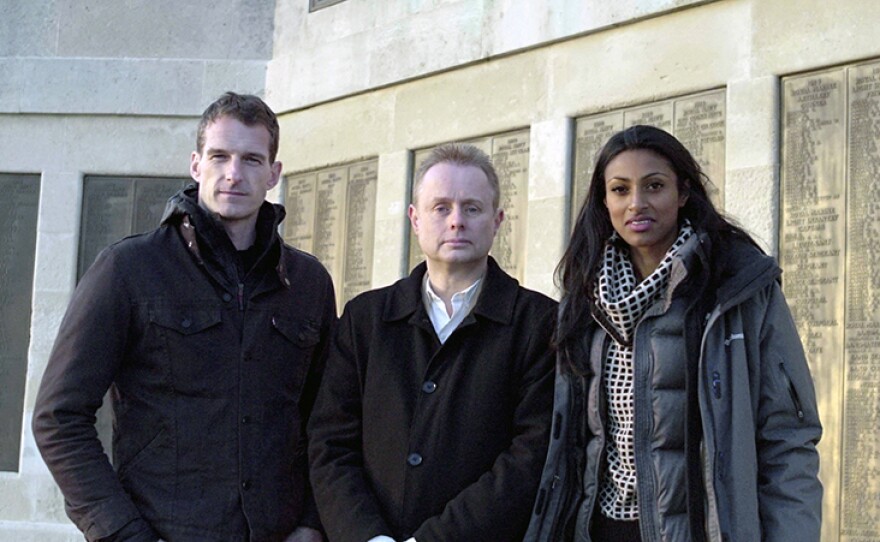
(595, 221, 694, 521)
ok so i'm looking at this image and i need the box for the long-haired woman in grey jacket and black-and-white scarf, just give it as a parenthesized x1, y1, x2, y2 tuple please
(526, 126, 822, 542)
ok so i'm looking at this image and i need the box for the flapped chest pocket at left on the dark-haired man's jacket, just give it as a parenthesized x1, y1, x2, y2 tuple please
(149, 304, 225, 396)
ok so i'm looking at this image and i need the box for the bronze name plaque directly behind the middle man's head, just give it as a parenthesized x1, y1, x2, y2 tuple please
(409, 129, 529, 280)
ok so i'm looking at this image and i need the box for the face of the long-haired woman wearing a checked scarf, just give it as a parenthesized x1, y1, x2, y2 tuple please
(605, 149, 687, 277)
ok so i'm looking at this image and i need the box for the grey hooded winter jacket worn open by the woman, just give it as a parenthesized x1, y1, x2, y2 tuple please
(525, 234, 822, 542)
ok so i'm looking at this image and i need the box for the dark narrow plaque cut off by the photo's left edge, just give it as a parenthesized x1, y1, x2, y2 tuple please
(0, 174, 40, 472)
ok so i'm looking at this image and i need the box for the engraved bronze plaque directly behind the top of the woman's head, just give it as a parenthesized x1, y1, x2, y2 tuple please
(571, 90, 727, 217)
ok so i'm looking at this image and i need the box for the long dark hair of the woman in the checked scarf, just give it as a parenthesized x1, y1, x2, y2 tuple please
(554, 125, 757, 370)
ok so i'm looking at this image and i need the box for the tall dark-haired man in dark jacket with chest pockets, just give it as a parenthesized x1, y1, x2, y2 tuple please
(33, 93, 336, 542)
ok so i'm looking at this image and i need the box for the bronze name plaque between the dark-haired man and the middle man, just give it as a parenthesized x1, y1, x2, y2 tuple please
(283, 159, 379, 309)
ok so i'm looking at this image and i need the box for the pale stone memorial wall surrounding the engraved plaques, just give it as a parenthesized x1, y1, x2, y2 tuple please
(0, 0, 880, 542)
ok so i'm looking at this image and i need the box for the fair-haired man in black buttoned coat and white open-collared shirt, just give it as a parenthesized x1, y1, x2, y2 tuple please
(309, 144, 556, 542)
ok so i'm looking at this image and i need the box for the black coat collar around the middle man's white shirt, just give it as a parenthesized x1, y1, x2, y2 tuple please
(382, 256, 519, 325)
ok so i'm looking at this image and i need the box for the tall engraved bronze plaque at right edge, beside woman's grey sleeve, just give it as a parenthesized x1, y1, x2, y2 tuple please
(780, 61, 880, 542)
